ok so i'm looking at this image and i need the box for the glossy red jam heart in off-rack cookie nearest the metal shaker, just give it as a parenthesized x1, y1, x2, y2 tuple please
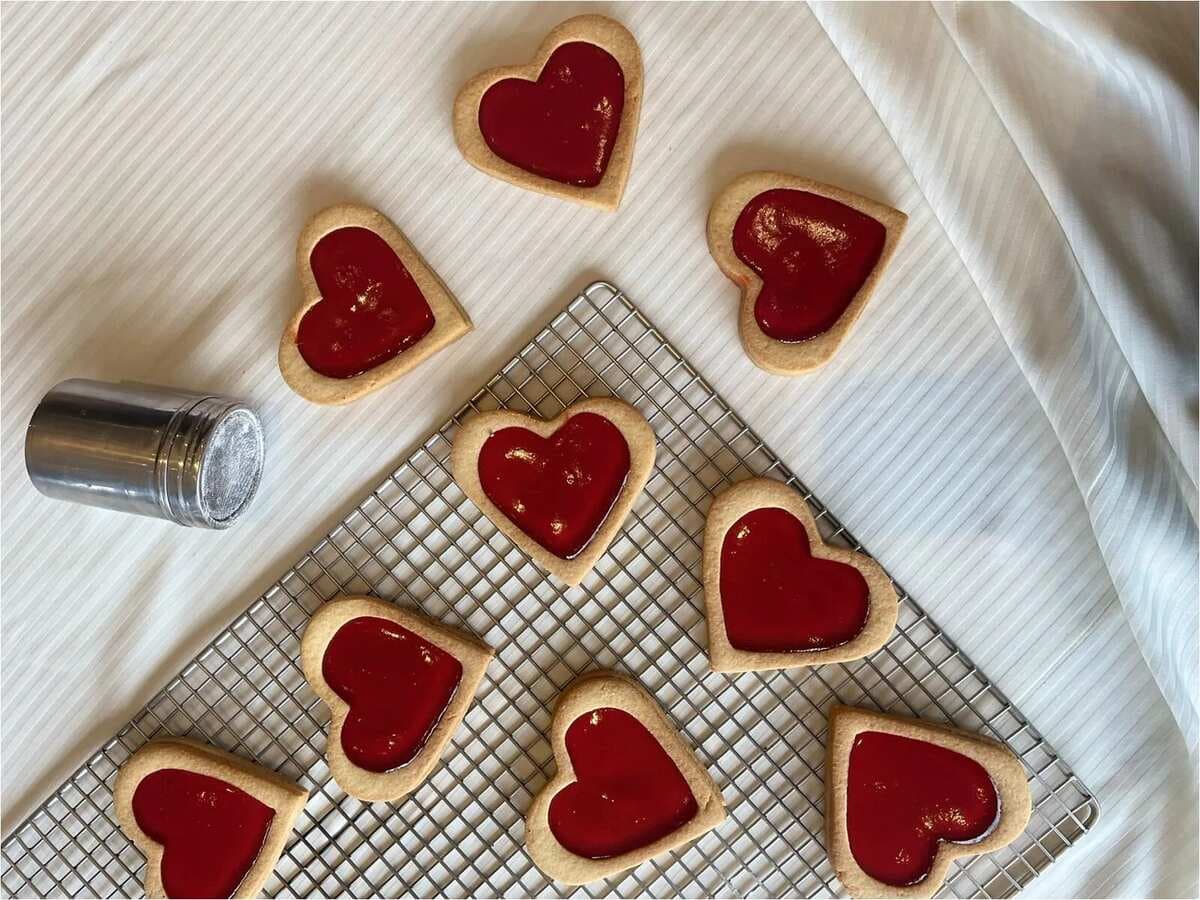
(296, 228, 433, 378)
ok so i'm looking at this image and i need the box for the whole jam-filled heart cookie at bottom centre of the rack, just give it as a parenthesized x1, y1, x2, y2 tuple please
(526, 672, 725, 884)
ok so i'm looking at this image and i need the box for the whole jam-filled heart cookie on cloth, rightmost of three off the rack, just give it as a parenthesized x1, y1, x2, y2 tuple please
(708, 172, 908, 374)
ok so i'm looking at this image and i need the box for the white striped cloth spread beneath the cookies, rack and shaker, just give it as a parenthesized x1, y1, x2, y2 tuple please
(0, 4, 1200, 896)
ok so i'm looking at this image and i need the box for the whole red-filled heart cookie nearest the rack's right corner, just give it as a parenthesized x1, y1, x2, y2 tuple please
(826, 707, 1032, 898)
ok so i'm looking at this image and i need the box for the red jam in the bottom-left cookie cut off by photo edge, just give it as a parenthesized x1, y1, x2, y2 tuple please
(133, 769, 275, 898)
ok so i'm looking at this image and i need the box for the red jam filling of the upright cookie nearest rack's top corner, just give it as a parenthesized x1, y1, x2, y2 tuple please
(479, 413, 629, 559)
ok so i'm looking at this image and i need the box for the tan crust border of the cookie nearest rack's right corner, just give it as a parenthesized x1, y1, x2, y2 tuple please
(826, 706, 1032, 899)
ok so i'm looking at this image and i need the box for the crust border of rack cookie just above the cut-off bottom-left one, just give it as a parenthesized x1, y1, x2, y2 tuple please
(300, 596, 496, 802)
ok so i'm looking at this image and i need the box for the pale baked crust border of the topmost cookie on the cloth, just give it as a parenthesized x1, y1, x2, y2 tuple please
(454, 16, 643, 212)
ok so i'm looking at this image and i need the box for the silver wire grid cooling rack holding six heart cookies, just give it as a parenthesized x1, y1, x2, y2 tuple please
(0, 283, 1098, 896)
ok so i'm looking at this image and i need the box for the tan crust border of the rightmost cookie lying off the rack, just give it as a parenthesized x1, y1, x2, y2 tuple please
(708, 172, 908, 376)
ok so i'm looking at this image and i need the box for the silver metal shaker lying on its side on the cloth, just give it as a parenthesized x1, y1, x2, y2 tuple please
(25, 378, 263, 528)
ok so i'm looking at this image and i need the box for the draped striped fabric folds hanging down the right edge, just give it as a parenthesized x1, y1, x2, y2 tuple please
(815, 5, 1200, 754)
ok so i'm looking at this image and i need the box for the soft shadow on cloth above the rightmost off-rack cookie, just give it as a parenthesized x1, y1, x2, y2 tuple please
(704, 140, 894, 206)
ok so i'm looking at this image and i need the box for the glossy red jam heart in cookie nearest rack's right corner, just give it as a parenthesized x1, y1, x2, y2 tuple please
(846, 731, 1000, 887)
